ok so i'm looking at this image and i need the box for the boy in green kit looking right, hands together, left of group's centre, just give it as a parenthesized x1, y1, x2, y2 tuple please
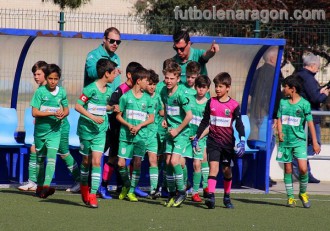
(117, 67, 154, 202)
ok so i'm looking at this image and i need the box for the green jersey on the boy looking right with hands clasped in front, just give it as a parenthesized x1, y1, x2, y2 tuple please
(119, 90, 155, 142)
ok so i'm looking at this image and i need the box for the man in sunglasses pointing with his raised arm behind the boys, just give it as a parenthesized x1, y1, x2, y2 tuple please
(173, 30, 219, 83)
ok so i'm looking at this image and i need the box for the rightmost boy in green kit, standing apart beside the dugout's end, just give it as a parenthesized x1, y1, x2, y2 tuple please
(276, 76, 320, 208)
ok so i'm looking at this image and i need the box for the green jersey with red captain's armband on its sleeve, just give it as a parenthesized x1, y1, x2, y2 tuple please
(77, 82, 112, 140)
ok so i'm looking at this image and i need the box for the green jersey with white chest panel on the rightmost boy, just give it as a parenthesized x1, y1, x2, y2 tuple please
(277, 97, 313, 147)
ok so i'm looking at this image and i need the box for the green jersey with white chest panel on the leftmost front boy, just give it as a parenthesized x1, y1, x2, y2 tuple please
(30, 86, 68, 137)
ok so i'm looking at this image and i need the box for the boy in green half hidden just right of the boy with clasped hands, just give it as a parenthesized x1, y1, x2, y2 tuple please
(146, 70, 164, 199)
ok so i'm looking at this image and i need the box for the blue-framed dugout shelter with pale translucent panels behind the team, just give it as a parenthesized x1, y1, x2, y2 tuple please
(0, 28, 285, 193)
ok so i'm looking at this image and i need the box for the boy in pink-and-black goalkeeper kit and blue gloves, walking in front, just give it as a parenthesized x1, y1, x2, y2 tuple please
(193, 72, 245, 209)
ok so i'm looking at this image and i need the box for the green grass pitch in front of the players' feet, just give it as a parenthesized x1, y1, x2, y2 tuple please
(0, 188, 330, 231)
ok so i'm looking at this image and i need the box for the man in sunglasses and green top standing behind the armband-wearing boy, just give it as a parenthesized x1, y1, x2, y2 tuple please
(84, 27, 121, 91)
